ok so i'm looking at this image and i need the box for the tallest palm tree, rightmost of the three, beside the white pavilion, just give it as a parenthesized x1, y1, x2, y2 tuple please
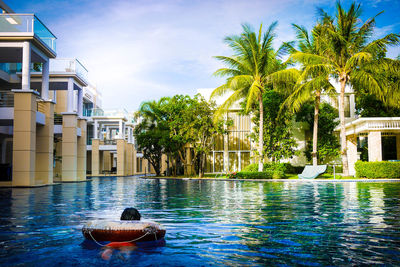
(286, 2, 399, 175)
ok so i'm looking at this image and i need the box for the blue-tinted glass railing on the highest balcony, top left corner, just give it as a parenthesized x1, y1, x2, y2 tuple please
(0, 13, 57, 52)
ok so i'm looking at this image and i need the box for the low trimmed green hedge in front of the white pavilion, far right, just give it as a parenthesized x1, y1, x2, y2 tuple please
(355, 161, 400, 178)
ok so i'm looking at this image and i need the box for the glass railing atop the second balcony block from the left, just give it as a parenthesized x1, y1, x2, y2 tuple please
(50, 58, 88, 82)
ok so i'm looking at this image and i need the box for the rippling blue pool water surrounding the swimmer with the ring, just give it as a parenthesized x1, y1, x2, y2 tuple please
(0, 177, 400, 267)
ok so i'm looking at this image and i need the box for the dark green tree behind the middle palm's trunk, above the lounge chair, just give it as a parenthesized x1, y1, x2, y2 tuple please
(296, 102, 340, 164)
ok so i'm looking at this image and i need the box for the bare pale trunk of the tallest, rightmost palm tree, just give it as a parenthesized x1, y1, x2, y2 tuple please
(339, 74, 349, 176)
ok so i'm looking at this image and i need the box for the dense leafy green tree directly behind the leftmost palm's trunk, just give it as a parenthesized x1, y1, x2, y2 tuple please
(250, 90, 296, 162)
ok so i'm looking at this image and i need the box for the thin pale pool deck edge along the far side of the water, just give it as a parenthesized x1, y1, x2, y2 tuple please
(139, 176, 400, 183)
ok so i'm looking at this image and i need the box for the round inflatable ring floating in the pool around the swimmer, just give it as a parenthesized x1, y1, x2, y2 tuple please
(82, 221, 166, 243)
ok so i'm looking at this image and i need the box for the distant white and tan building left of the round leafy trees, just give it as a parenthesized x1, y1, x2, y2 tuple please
(87, 109, 154, 176)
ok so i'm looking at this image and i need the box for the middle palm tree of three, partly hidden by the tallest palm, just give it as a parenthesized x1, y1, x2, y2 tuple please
(272, 24, 334, 166)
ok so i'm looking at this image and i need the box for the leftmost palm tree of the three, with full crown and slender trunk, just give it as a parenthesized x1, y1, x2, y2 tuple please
(211, 22, 282, 171)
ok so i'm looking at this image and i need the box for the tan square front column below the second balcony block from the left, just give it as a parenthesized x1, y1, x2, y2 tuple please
(61, 113, 78, 182)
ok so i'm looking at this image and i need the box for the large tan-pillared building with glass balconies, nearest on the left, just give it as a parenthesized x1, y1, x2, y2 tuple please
(0, 1, 101, 186)
